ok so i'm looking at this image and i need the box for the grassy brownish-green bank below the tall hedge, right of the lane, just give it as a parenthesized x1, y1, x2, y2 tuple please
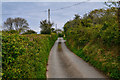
(66, 38, 120, 79)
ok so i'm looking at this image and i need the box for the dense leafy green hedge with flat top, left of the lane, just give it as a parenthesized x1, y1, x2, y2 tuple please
(2, 33, 57, 79)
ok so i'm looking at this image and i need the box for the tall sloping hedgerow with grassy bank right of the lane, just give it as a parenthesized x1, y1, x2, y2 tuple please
(64, 8, 120, 79)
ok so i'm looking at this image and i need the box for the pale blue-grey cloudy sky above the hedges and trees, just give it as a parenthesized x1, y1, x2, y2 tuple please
(2, 2, 106, 32)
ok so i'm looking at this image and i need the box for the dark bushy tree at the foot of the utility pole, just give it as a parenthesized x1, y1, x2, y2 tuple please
(40, 20, 53, 34)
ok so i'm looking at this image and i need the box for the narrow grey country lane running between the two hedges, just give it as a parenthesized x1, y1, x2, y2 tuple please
(46, 38, 105, 78)
